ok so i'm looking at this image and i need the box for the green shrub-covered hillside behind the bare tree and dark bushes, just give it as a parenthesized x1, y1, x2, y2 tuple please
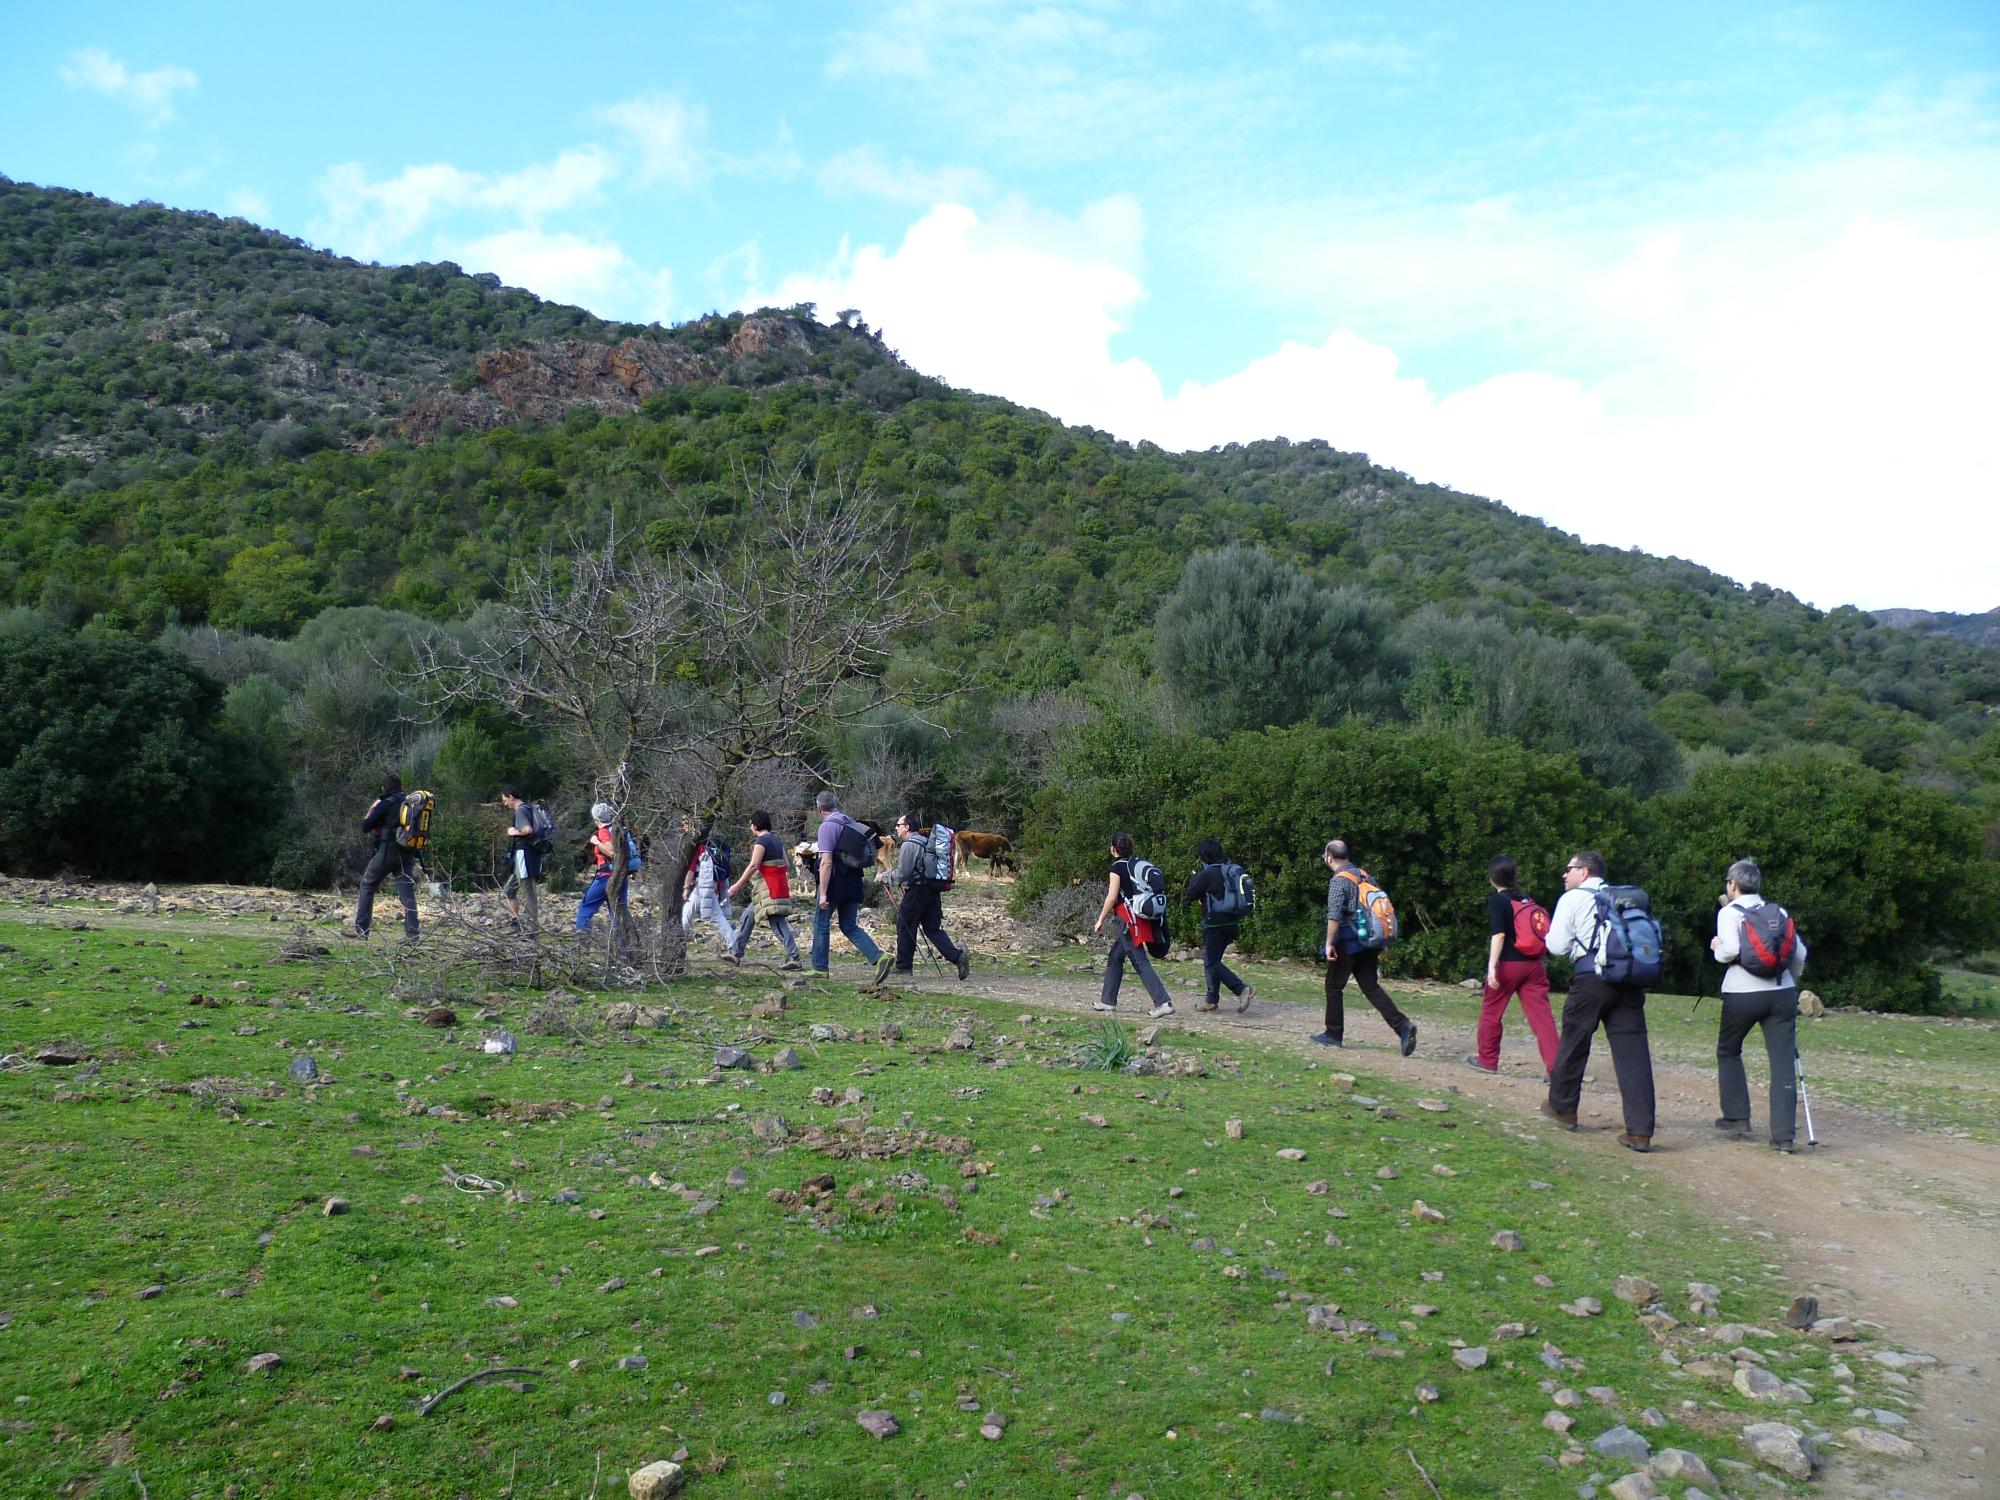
(0, 182, 2000, 1012)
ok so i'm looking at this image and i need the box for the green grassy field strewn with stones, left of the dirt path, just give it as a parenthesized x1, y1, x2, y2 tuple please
(0, 914, 1894, 1500)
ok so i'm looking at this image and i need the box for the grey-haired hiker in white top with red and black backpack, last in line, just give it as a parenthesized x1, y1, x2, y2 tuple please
(1708, 860, 1810, 1154)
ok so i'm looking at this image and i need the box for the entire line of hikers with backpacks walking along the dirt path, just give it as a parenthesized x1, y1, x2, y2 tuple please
(354, 792, 1806, 1152)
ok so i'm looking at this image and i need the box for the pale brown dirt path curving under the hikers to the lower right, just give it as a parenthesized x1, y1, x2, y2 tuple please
(916, 972, 2000, 1496)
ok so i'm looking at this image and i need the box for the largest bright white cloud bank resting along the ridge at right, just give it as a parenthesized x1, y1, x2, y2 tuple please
(762, 198, 2000, 610)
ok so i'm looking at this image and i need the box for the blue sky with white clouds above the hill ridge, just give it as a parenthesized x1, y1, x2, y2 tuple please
(0, 0, 2000, 610)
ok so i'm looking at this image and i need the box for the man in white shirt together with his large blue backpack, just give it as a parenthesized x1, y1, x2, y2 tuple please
(1542, 850, 1660, 1152)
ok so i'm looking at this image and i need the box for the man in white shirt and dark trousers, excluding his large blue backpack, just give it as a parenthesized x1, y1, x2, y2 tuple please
(1542, 850, 1654, 1152)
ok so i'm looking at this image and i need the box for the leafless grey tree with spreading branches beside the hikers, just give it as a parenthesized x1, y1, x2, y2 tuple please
(418, 462, 936, 974)
